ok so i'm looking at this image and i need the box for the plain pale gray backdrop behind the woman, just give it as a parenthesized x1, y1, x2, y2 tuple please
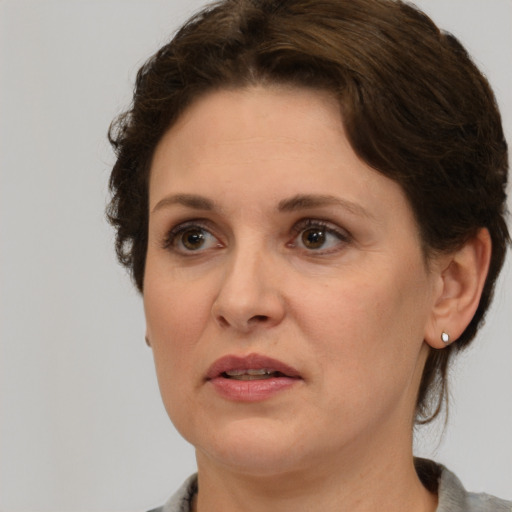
(0, 0, 512, 512)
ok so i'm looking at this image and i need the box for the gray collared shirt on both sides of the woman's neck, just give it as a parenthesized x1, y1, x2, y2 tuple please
(150, 461, 512, 512)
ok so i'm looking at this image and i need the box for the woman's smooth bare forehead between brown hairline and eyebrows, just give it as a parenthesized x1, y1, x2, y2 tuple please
(150, 87, 412, 224)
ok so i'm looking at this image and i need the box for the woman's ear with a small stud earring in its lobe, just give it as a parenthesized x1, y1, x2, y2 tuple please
(425, 228, 492, 349)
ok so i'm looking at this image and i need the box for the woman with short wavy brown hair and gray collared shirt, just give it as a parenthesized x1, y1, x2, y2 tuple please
(109, 0, 511, 512)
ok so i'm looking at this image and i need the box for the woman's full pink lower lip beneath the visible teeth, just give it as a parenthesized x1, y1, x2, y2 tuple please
(208, 377, 300, 402)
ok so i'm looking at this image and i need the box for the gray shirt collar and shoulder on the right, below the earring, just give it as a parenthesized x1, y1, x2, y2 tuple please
(415, 459, 512, 512)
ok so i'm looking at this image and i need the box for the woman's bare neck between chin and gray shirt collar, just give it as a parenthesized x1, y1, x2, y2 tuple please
(194, 430, 437, 512)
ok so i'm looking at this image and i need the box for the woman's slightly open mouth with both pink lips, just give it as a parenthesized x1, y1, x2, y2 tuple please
(206, 354, 303, 402)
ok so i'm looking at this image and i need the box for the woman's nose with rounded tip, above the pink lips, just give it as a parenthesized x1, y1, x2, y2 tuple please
(212, 248, 285, 333)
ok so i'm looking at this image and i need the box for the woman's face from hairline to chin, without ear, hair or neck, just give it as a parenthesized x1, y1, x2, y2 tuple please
(144, 87, 437, 475)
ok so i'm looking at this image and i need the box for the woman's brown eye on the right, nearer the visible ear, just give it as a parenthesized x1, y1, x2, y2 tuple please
(289, 219, 350, 253)
